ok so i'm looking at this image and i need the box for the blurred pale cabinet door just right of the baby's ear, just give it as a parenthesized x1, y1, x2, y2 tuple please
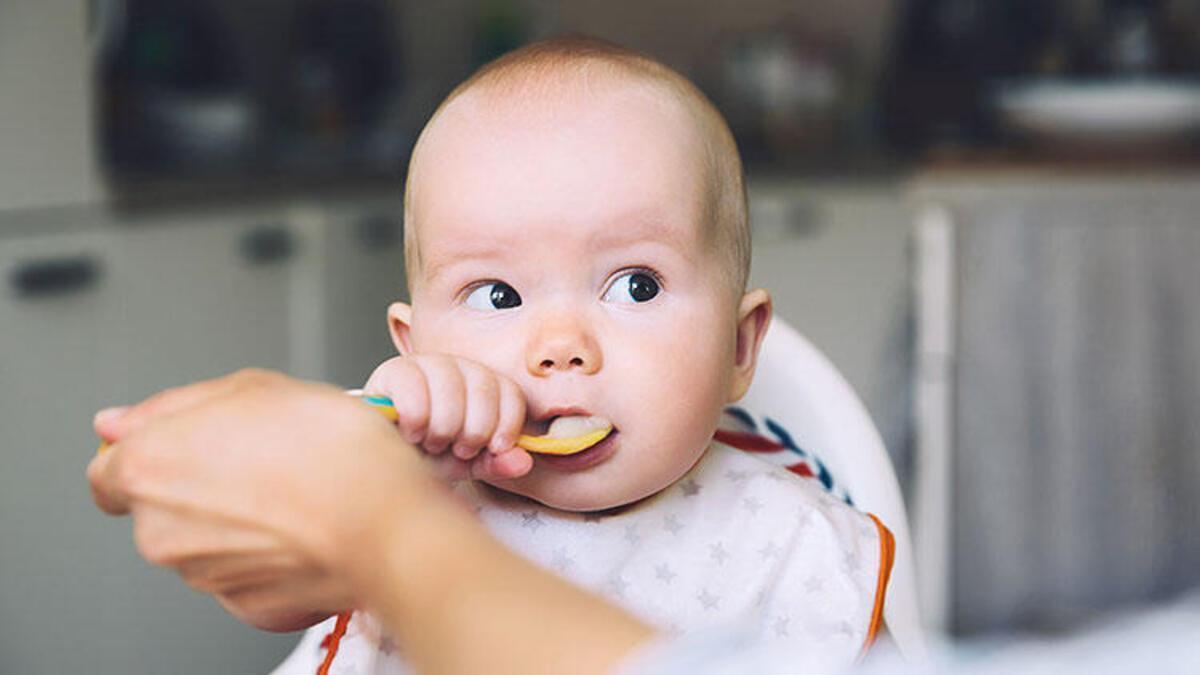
(749, 179, 911, 441)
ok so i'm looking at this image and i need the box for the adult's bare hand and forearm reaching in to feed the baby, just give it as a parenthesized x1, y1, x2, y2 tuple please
(88, 371, 654, 674)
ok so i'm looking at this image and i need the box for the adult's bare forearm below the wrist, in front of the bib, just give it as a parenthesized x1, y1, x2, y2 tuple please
(364, 487, 654, 674)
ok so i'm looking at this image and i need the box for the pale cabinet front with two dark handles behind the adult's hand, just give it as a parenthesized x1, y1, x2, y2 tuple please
(0, 208, 300, 673)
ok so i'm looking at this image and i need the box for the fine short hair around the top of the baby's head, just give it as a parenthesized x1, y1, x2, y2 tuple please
(404, 35, 750, 294)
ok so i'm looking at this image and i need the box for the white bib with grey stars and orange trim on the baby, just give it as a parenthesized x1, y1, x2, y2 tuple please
(276, 441, 889, 674)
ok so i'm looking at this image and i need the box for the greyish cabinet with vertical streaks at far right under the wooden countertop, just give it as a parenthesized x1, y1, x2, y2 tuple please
(912, 171, 1200, 635)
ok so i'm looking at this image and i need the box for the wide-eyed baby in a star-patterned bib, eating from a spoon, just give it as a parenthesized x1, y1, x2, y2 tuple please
(278, 38, 890, 673)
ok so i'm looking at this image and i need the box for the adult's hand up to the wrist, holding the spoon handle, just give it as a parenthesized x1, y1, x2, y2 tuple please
(88, 371, 444, 631)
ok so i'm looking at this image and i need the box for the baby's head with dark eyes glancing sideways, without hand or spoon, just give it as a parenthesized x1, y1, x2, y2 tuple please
(389, 38, 770, 510)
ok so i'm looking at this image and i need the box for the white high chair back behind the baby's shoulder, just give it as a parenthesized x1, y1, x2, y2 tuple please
(737, 316, 926, 659)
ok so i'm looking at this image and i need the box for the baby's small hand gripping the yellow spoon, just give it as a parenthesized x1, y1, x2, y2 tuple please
(364, 354, 533, 480)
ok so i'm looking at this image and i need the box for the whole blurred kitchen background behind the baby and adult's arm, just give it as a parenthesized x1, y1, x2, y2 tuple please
(0, 0, 1200, 673)
